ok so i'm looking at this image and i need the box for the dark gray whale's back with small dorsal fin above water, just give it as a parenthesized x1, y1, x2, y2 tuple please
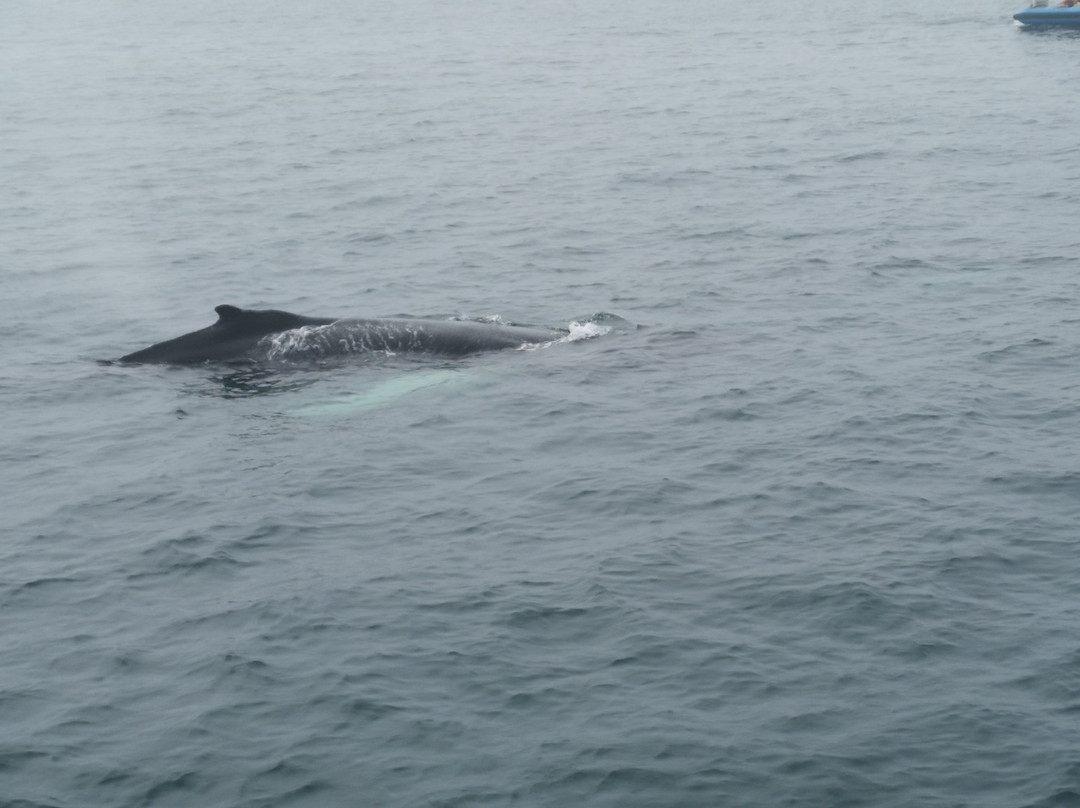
(120, 306, 562, 365)
